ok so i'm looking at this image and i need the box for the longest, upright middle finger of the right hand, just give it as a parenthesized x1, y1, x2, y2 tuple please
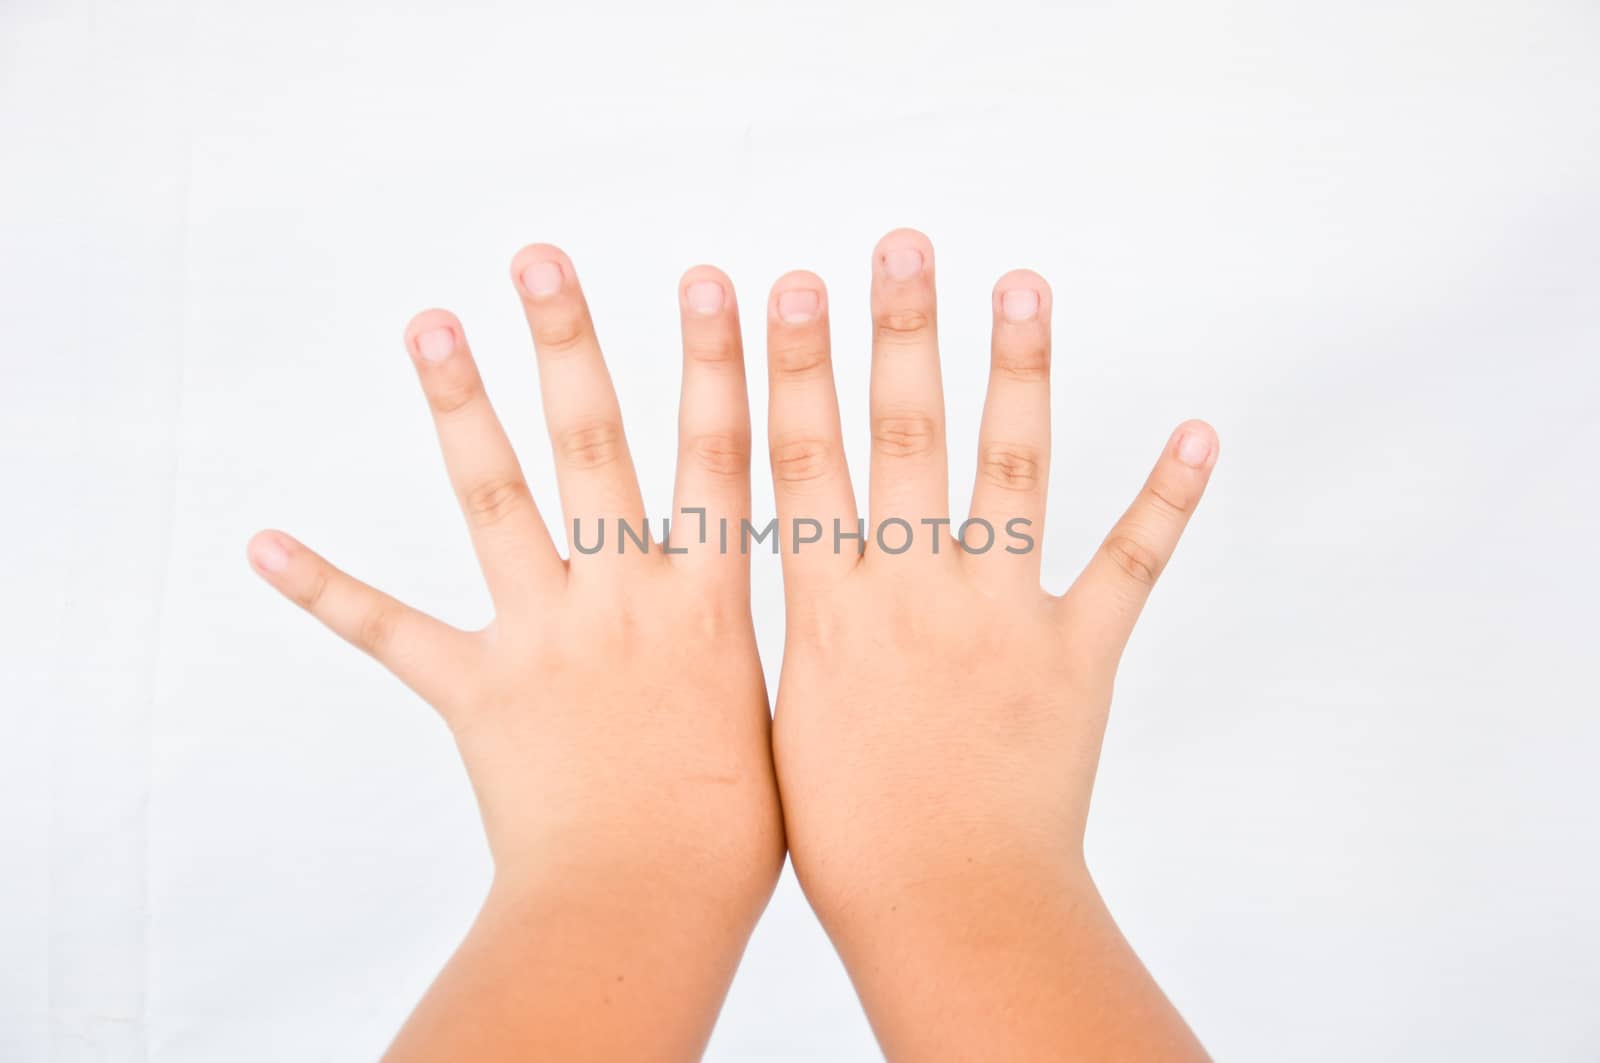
(869, 229, 950, 540)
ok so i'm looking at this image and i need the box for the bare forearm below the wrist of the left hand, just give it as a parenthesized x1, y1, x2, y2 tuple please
(386, 879, 765, 1063)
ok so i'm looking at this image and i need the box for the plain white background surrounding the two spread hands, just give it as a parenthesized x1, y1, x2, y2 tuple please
(0, 0, 1600, 1063)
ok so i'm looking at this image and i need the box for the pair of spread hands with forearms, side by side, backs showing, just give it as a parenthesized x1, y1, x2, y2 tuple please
(250, 231, 1218, 1060)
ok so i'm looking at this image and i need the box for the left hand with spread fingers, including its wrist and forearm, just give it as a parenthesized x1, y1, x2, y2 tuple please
(250, 245, 784, 1060)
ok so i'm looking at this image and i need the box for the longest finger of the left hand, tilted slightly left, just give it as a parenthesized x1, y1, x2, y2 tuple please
(512, 243, 645, 565)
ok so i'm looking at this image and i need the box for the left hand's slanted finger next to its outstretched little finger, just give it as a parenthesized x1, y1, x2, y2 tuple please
(405, 311, 563, 615)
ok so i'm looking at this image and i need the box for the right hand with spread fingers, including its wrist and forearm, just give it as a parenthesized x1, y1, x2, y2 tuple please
(768, 231, 1218, 1060)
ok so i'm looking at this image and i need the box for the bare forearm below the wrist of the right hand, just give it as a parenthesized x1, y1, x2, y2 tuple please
(830, 871, 1206, 1061)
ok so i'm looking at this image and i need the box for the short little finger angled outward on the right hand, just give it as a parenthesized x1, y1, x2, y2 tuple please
(1064, 421, 1218, 658)
